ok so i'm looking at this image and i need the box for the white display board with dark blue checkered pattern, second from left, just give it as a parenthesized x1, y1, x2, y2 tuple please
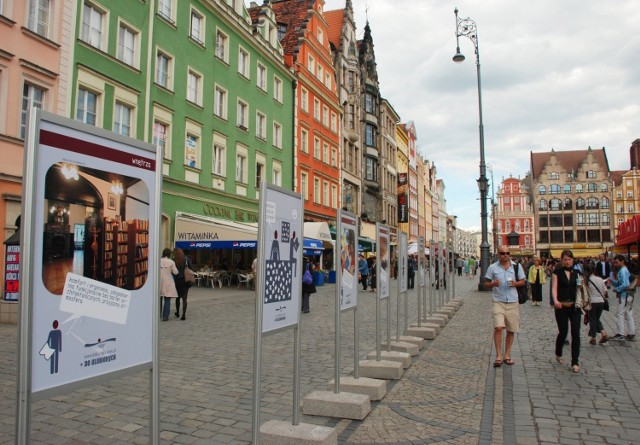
(258, 185, 303, 333)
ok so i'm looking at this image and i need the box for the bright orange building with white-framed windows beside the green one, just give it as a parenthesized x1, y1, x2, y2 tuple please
(273, 0, 341, 225)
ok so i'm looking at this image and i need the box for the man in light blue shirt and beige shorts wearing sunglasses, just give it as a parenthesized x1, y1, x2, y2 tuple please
(485, 246, 525, 368)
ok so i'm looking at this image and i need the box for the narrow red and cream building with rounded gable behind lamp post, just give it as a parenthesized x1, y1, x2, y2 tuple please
(495, 177, 536, 257)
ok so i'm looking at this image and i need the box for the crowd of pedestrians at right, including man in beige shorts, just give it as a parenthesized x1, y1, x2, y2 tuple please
(484, 250, 640, 373)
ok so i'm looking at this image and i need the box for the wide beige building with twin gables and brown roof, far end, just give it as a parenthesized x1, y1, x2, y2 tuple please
(530, 147, 613, 258)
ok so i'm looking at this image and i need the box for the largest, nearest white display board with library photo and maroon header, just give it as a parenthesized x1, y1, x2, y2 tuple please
(24, 113, 160, 395)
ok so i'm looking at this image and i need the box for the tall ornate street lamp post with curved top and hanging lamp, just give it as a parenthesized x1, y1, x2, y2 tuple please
(453, 8, 490, 290)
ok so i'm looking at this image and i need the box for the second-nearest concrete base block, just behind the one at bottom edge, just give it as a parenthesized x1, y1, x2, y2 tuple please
(302, 391, 371, 420)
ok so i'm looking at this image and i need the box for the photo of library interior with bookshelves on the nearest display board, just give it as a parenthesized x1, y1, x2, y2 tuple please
(42, 162, 149, 295)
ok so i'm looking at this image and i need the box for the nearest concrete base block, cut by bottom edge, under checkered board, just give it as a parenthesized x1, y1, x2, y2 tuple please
(260, 420, 338, 445)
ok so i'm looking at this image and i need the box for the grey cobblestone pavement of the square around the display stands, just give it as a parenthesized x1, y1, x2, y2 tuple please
(0, 277, 640, 445)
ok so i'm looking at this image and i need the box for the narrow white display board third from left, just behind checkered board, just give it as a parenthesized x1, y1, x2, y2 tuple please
(336, 210, 358, 311)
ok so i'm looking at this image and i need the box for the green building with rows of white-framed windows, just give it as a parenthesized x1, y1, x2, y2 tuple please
(69, 0, 294, 260)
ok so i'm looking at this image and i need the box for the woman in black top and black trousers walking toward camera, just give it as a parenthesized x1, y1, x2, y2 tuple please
(551, 250, 582, 372)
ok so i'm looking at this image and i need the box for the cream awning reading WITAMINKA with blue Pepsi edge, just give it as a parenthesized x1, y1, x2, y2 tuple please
(174, 212, 258, 249)
